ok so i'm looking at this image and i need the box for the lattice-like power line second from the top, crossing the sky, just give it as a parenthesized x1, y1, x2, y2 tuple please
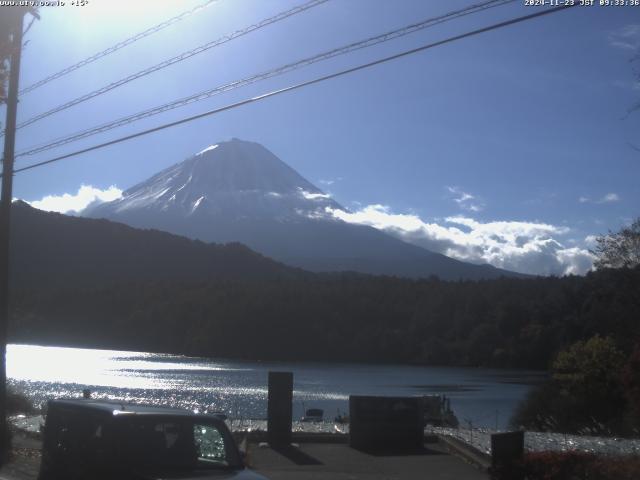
(8, 0, 329, 135)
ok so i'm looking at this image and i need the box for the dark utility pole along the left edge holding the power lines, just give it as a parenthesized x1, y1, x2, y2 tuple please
(0, 7, 26, 465)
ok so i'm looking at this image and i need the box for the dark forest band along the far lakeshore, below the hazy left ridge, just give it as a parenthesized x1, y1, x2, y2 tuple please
(11, 268, 640, 368)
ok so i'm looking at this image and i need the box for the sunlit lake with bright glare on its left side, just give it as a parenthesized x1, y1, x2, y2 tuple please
(7, 345, 545, 429)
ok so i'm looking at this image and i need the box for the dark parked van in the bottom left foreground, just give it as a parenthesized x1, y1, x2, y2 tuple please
(38, 399, 266, 480)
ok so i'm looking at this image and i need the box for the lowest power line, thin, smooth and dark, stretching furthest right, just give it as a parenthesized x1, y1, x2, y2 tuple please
(6, 4, 578, 177)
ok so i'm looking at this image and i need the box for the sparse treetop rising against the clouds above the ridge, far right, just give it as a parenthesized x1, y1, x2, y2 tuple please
(592, 217, 640, 268)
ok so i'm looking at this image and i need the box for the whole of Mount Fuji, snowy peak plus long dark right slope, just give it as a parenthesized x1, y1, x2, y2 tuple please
(82, 139, 519, 280)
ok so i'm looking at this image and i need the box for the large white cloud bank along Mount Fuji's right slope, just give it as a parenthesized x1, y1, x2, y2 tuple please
(326, 205, 593, 275)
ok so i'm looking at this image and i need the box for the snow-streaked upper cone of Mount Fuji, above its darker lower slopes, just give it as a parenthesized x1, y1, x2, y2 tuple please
(86, 138, 341, 221)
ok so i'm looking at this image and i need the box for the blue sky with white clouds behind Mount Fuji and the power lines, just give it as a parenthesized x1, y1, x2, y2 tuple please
(5, 0, 640, 275)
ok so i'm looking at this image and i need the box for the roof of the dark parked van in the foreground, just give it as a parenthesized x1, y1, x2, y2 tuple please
(49, 398, 228, 420)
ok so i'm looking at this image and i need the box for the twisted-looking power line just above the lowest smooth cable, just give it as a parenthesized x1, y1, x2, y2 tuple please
(16, 0, 515, 157)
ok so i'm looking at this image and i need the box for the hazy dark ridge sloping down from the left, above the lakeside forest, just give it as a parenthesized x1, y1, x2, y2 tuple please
(11, 201, 303, 288)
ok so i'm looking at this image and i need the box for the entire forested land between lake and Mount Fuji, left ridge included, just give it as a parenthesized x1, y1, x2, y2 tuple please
(9, 202, 640, 369)
